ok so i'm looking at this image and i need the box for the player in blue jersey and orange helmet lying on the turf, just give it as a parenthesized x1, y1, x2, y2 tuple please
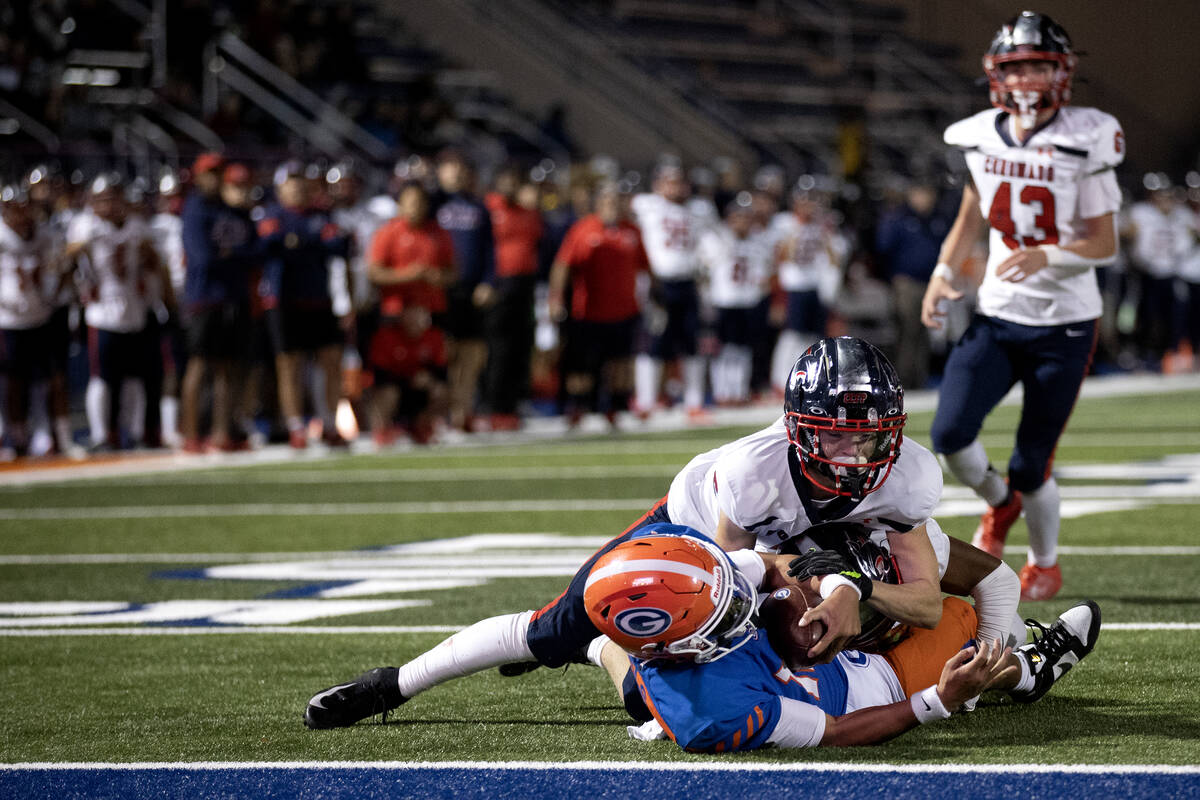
(584, 525, 1100, 753)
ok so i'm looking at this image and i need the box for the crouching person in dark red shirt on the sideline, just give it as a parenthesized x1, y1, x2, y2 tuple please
(367, 306, 446, 446)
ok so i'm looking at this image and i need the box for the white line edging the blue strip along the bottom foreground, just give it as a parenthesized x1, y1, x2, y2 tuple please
(0, 760, 1200, 775)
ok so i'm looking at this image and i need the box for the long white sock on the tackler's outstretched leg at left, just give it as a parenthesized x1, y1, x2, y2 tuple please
(397, 612, 534, 697)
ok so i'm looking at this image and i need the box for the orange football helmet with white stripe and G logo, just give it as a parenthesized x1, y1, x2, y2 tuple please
(583, 534, 757, 663)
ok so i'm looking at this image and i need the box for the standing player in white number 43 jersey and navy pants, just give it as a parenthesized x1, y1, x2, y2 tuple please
(922, 11, 1124, 600)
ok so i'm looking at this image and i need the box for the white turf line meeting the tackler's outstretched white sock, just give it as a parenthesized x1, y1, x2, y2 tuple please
(0, 622, 1200, 638)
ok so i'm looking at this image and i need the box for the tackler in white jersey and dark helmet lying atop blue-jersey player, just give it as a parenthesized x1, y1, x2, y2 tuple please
(304, 337, 1025, 734)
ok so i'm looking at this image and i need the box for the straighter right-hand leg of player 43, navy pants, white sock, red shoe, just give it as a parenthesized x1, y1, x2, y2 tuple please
(1008, 321, 1097, 600)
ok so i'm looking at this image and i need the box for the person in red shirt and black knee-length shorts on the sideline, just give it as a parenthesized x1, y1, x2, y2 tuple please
(550, 184, 650, 427)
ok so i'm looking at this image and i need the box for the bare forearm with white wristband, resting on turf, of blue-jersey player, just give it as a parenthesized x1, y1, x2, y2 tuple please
(769, 642, 1015, 747)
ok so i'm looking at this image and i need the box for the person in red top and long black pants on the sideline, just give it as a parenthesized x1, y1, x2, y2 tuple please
(484, 168, 542, 431)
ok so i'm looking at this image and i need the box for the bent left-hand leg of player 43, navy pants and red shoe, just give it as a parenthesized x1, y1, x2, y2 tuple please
(930, 315, 1021, 558)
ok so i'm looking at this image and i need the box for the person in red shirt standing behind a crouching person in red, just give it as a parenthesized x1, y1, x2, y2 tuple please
(367, 184, 457, 323)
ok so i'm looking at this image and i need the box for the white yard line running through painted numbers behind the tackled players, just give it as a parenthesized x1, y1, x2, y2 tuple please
(0, 542, 1200, 566)
